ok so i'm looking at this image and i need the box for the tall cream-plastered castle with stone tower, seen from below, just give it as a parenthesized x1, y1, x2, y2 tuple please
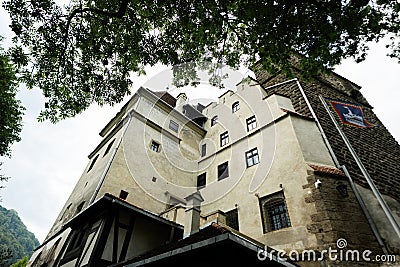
(30, 70, 400, 266)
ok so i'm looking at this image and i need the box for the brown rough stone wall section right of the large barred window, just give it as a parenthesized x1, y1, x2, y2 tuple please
(301, 170, 383, 266)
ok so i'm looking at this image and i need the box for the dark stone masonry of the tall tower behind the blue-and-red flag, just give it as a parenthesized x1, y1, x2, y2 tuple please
(256, 71, 400, 201)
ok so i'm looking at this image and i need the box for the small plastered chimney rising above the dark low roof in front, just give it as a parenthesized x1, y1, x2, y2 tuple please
(183, 191, 204, 237)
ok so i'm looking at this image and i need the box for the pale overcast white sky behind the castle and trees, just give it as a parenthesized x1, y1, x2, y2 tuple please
(0, 8, 400, 245)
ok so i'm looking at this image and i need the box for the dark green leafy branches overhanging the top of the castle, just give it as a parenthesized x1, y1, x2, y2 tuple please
(3, 0, 400, 122)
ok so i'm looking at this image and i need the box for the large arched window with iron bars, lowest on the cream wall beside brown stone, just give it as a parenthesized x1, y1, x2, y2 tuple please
(260, 192, 291, 233)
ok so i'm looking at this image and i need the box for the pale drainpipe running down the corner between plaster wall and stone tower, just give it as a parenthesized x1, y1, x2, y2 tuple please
(295, 78, 388, 254)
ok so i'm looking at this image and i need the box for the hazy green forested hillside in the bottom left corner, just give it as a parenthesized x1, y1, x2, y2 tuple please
(0, 206, 39, 264)
